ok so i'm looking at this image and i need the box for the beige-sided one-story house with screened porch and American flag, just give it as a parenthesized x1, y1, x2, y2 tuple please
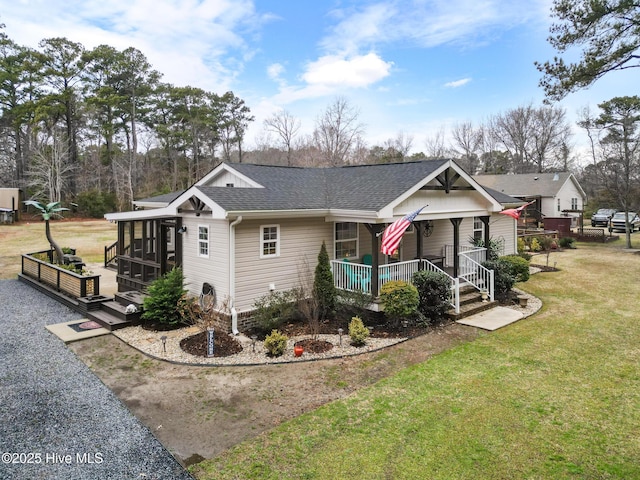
(105, 160, 523, 331)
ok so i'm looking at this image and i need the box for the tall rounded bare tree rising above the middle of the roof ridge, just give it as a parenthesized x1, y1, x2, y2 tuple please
(313, 97, 364, 166)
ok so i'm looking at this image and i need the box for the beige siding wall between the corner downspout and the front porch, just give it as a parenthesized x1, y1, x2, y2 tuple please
(235, 218, 333, 312)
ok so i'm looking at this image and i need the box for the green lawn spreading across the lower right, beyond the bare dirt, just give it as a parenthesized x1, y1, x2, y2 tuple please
(192, 245, 640, 479)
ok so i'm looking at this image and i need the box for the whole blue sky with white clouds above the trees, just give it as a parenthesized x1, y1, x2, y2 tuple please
(0, 0, 640, 161)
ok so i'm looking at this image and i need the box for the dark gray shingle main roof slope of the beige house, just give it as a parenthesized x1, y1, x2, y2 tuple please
(197, 160, 447, 211)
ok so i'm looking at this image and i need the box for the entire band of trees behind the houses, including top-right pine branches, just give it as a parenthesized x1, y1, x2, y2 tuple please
(0, 0, 640, 221)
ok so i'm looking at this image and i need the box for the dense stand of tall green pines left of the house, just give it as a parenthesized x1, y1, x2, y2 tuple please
(0, 26, 253, 208)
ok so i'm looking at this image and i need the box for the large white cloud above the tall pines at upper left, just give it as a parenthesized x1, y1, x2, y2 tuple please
(0, 0, 271, 91)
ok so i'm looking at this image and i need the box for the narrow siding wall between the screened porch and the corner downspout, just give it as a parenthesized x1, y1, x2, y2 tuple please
(182, 217, 229, 303)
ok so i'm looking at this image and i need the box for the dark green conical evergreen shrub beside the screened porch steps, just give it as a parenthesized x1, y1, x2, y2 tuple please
(141, 268, 187, 326)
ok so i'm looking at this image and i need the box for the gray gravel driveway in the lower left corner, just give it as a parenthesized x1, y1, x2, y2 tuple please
(0, 280, 192, 480)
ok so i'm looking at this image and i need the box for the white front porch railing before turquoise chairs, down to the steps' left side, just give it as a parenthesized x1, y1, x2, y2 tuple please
(331, 259, 460, 313)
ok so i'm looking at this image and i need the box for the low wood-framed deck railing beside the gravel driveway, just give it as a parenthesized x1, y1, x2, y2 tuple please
(22, 251, 100, 299)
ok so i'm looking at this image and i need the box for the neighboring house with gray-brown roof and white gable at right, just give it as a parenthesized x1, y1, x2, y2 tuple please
(473, 172, 587, 228)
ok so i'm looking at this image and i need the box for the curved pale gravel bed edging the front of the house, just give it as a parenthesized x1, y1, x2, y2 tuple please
(113, 326, 406, 366)
